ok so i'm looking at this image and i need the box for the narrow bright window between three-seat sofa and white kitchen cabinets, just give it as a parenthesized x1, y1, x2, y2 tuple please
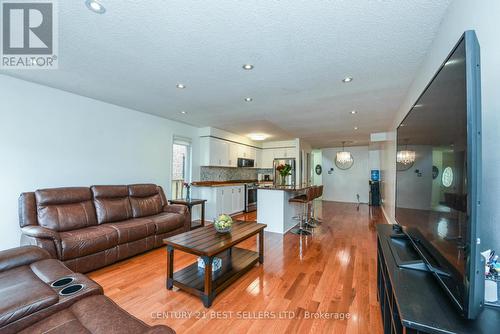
(171, 136, 191, 199)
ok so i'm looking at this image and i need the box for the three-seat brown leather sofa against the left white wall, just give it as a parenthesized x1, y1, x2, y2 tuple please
(19, 184, 191, 273)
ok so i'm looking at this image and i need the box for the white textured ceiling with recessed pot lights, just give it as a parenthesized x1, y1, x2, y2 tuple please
(2, 0, 451, 147)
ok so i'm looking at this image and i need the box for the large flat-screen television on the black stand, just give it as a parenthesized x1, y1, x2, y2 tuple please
(396, 31, 484, 319)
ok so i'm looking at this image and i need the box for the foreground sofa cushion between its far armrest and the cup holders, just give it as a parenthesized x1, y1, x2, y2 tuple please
(0, 266, 59, 327)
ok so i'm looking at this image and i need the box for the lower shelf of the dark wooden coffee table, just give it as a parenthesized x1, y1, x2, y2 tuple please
(167, 247, 259, 307)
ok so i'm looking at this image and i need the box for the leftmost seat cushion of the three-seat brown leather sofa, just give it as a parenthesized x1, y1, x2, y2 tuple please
(60, 225, 118, 260)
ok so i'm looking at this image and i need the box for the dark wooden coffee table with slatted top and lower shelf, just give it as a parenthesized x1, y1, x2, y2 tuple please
(163, 222, 267, 307)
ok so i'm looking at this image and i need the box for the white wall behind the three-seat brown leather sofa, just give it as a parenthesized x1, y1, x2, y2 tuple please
(0, 75, 199, 249)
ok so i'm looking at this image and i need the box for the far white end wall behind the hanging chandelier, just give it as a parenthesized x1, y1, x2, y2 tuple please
(322, 146, 370, 203)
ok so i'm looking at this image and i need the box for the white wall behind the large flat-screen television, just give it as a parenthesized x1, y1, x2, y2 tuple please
(382, 0, 500, 248)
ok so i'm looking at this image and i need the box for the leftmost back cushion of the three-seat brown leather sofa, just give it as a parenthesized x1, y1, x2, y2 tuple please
(35, 188, 97, 231)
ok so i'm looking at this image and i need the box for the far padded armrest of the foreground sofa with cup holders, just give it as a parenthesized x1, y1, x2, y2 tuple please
(0, 246, 51, 272)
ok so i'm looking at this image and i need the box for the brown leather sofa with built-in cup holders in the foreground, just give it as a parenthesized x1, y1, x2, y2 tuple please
(0, 246, 174, 334)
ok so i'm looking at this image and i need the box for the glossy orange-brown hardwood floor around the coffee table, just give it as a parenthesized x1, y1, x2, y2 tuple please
(90, 202, 385, 334)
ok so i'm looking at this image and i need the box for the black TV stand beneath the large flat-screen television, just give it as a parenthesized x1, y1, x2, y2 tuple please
(377, 224, 500, 334)
